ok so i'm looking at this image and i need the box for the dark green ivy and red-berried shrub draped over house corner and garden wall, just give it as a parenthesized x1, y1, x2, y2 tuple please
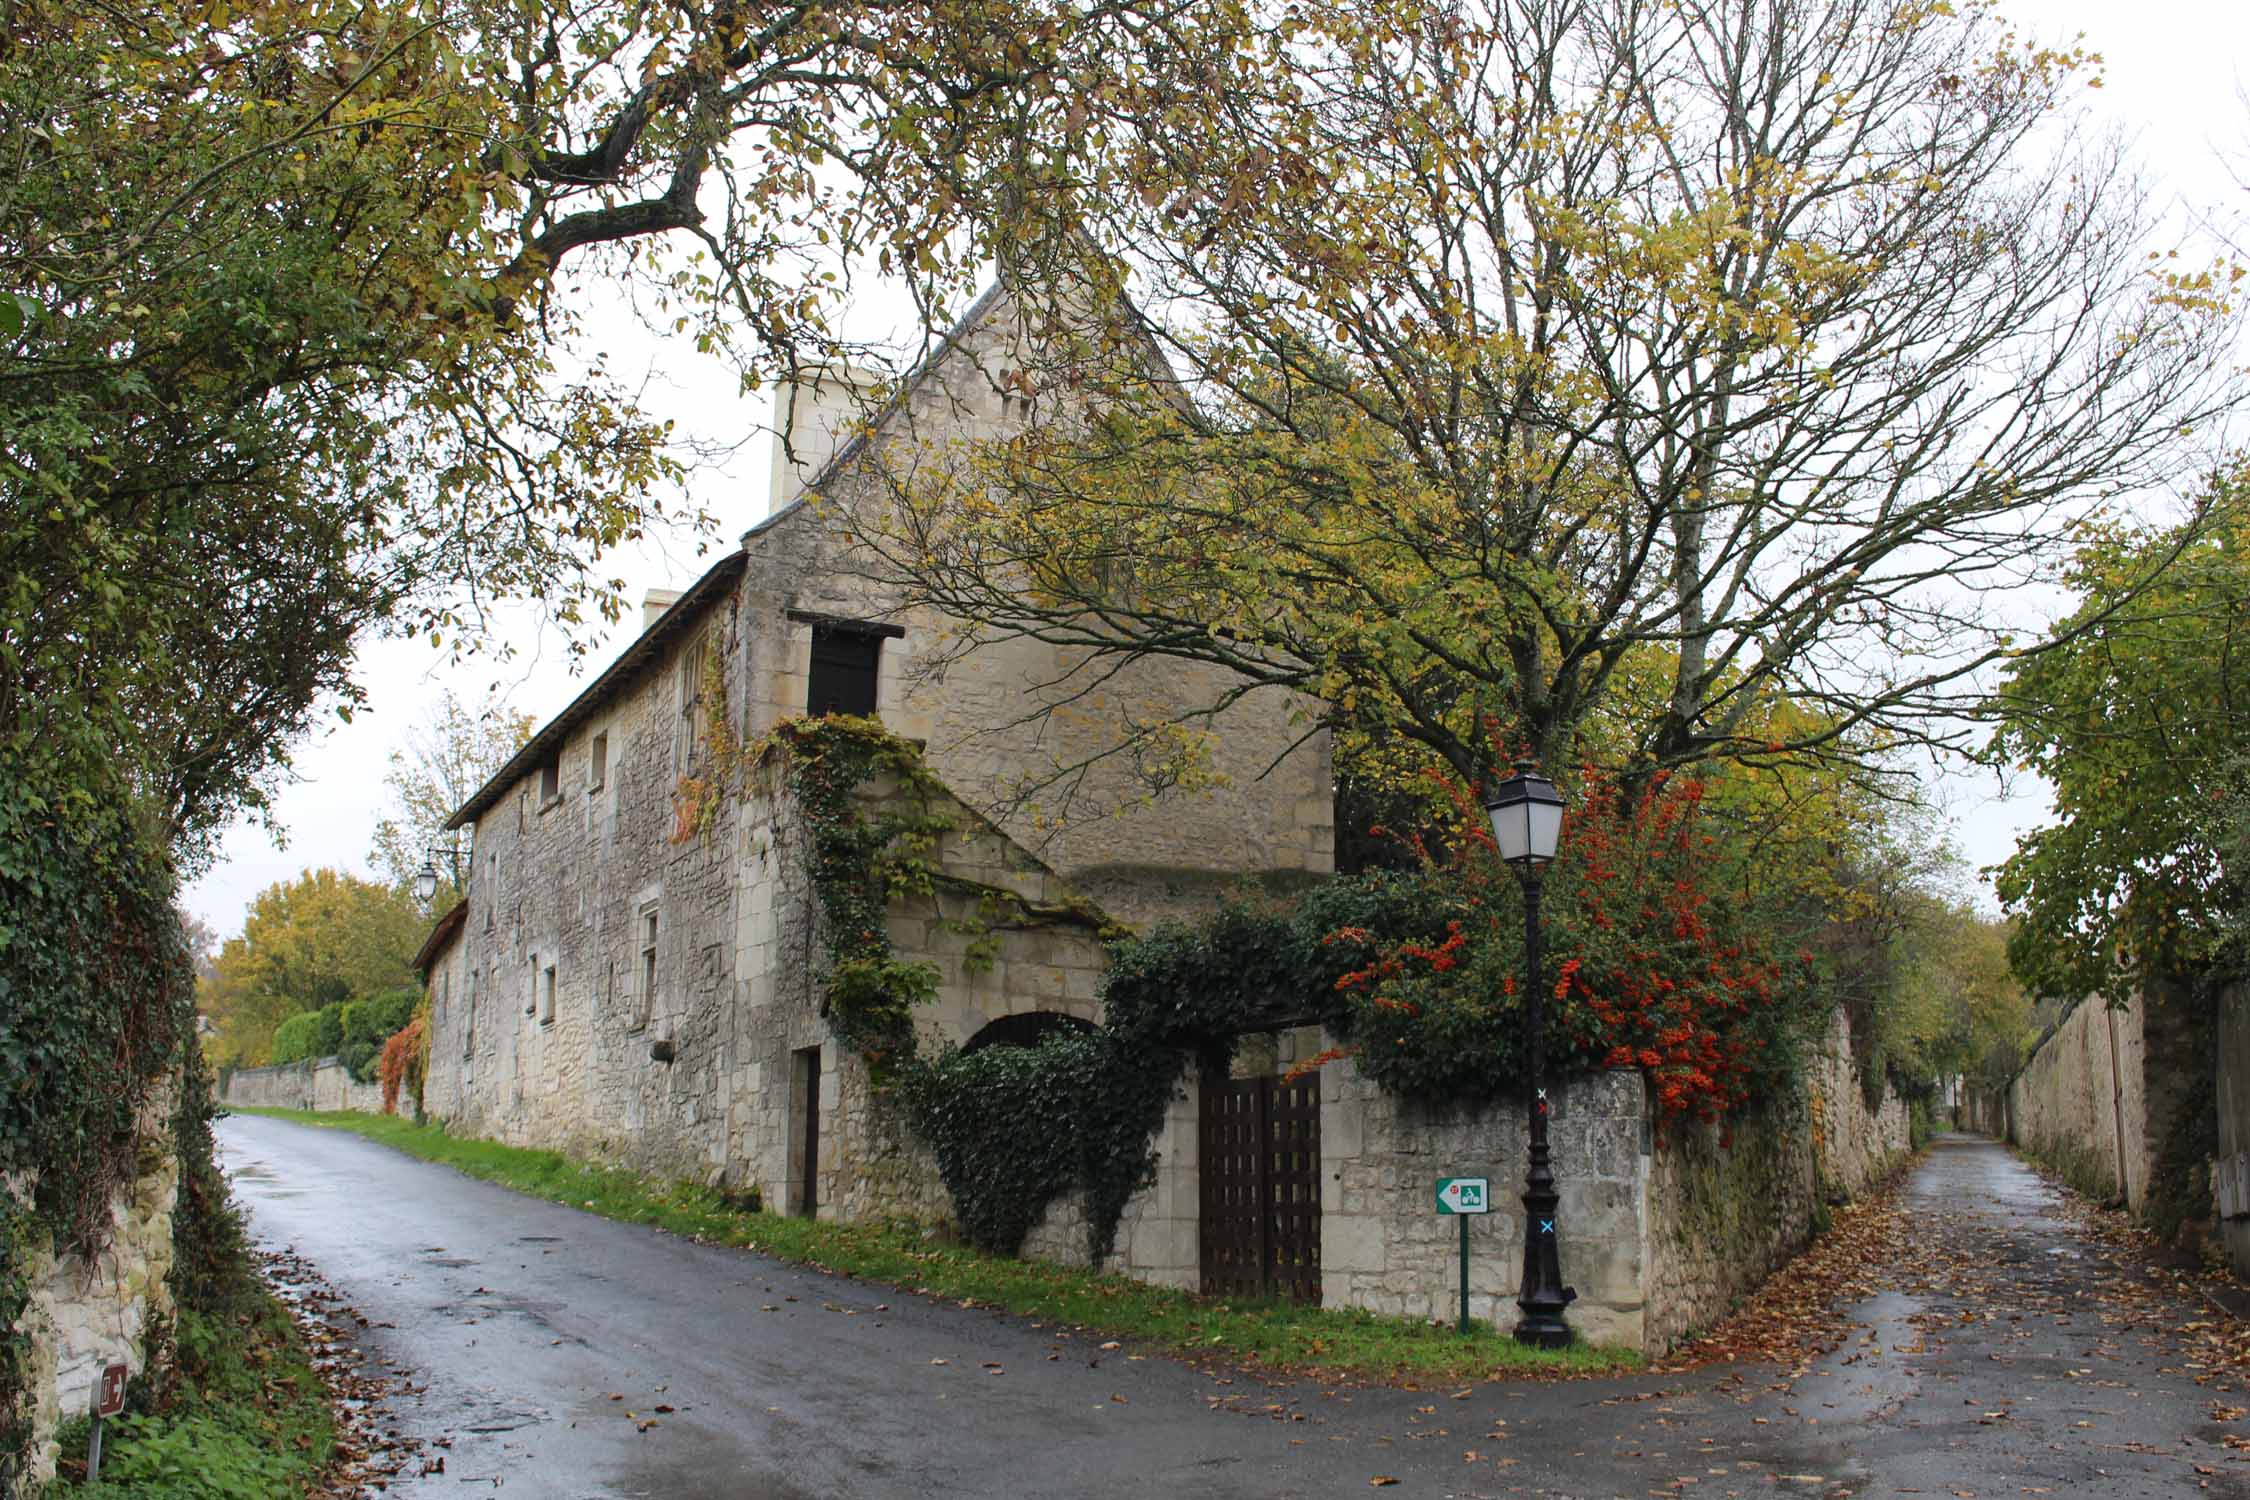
(738, 715, 1818, 1262)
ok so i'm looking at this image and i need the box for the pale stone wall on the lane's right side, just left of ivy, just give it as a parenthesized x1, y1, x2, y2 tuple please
(2007, 994, 2151, 1212)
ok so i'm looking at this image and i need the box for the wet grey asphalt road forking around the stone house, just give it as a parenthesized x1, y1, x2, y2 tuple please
(218, 1115, 2250, 1500)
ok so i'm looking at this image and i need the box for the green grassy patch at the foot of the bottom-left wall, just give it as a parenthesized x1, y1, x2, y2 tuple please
(43, 1289, 335, 1500)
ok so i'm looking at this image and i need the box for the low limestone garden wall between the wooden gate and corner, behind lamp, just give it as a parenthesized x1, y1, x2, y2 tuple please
(1321, 1061, 1652, 1347)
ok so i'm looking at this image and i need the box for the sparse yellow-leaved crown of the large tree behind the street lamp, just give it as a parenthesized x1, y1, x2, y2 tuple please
(855, 0, 2239, 809)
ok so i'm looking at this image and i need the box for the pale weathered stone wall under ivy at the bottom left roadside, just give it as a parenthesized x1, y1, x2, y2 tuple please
(0, 1086, 180, 1491)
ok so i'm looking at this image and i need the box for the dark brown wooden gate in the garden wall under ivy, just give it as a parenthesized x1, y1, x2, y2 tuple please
(1197, 1075, 1321, 1302)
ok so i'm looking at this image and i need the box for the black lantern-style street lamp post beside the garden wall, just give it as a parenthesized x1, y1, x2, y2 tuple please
(1485, 760, 1577, 1349)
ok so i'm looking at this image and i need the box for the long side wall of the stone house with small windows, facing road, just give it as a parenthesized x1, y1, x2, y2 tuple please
(423, 575, 743, 1181)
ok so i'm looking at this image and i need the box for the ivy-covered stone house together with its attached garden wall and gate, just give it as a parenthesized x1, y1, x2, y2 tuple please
(351, 273, 1906, 1347)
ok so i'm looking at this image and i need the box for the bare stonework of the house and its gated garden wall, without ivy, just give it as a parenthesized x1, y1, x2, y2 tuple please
(421, 275, 1906, 1349)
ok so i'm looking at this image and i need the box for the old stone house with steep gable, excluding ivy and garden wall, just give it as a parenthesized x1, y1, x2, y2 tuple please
(423, 273, 1334, 1280)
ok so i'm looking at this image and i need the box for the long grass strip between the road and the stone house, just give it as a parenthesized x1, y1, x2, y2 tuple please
(236, 1109, 1640, 1383)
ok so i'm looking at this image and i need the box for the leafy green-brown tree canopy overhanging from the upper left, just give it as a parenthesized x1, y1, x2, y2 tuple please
(0, 0, 1235, 855)
